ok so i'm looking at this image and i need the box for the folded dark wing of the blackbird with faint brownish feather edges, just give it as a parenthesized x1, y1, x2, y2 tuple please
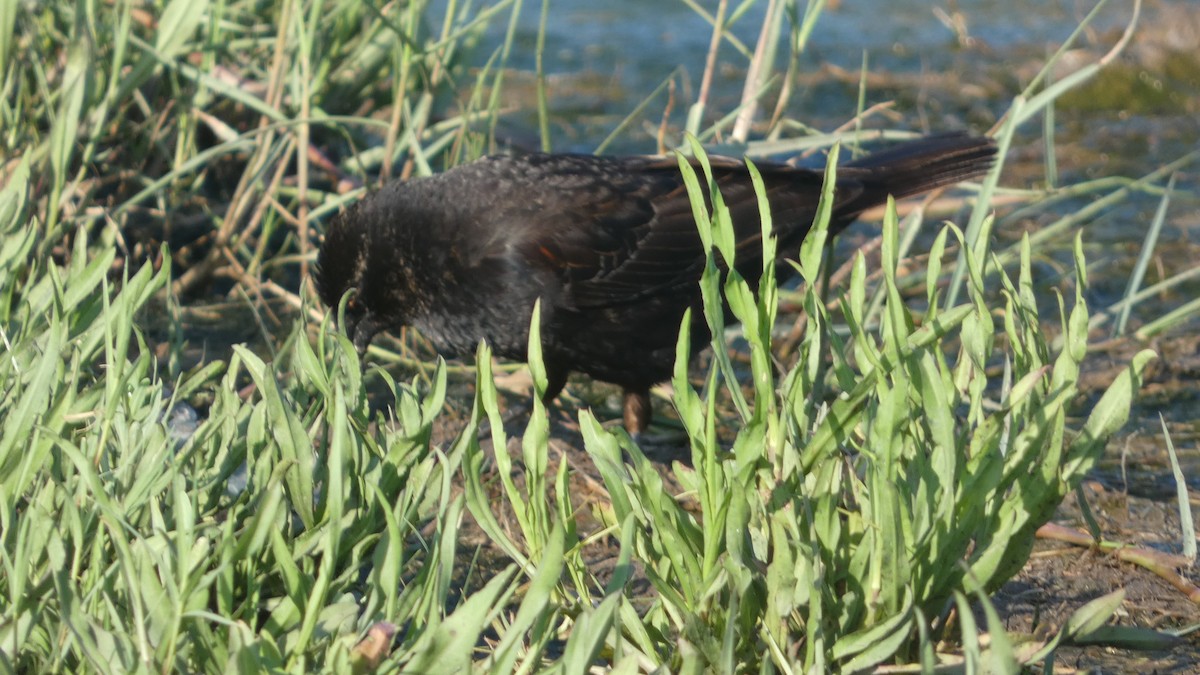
(518, 157, 860, 309)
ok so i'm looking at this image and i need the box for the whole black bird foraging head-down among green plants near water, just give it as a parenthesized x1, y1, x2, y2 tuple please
(317, 135, 995, 432)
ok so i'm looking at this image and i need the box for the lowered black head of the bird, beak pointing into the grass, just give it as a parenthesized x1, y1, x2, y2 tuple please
(314, 205, 404, 356)
